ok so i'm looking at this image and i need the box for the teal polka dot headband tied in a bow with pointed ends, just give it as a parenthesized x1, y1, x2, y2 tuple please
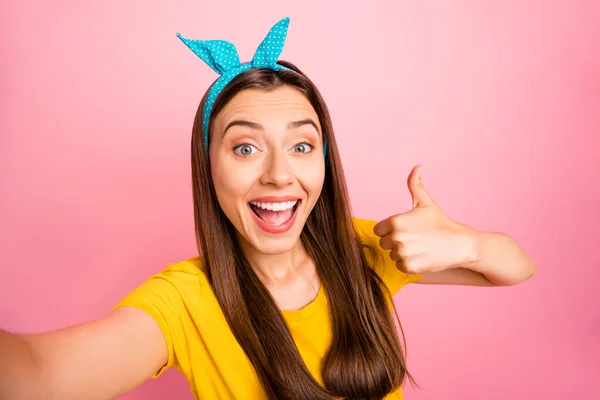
(177, 17, 327, 154)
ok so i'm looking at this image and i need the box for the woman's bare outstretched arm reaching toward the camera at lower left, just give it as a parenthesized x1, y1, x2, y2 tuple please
(0, 307, 167, 400)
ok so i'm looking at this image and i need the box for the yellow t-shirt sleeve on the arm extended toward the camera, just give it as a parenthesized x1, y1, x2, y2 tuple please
(113, 264, 199, 378)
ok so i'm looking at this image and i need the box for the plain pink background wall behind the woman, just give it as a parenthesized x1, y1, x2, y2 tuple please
(0, 0, 600, 400)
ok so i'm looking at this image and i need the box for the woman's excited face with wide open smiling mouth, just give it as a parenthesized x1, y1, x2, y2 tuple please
(209, 86, 325, 254)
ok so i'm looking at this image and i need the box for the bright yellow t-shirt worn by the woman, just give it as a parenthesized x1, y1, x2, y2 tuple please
(114, 219, 420, 400)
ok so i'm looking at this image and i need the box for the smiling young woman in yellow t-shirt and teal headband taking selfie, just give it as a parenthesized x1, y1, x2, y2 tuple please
(0, 19, 535, 400)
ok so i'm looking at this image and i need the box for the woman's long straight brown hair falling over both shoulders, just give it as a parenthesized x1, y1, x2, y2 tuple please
(191, 61, 410, 400)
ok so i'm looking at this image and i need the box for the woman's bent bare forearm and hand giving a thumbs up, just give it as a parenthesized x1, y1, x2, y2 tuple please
(373, 166, 535, 286)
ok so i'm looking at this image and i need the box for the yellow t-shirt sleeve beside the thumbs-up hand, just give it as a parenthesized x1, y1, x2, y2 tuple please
(353, 218, 423, 295)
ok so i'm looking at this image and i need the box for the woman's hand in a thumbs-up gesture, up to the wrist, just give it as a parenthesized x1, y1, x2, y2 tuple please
(374, 165, 476, 274)
